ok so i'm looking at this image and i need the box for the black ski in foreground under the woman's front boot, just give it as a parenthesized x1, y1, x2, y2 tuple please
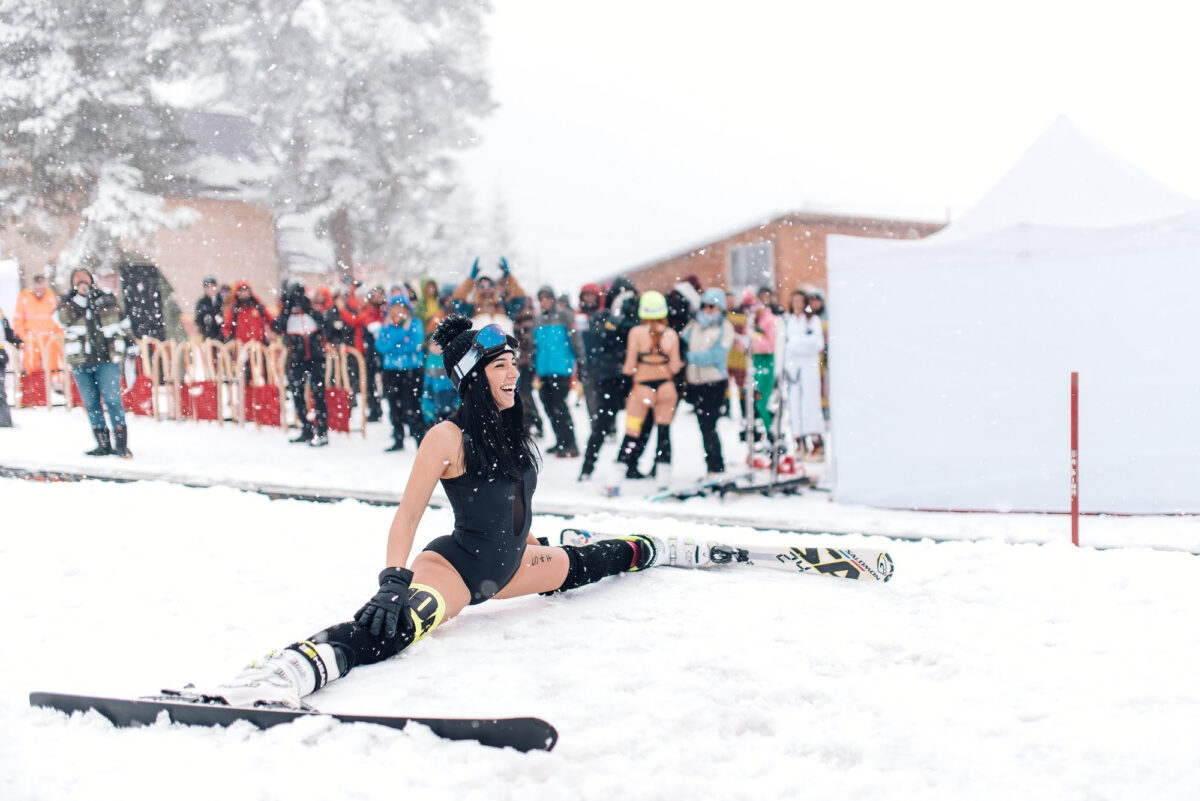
(29, 693, 558, 751)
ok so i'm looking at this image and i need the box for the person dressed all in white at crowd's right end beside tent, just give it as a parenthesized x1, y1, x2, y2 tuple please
(784, 289, 826, 460)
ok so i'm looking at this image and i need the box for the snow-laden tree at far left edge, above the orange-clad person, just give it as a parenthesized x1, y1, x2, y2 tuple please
(0, 0, 209, 271)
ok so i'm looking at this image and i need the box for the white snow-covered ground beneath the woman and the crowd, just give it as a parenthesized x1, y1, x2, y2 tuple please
(0, 410, 1200, 801)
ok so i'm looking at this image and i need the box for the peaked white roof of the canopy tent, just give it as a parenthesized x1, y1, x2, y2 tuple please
(928, 116, 1200, 243)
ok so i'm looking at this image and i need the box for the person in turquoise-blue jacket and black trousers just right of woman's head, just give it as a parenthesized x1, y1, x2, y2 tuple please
(533, 287, 583, 458)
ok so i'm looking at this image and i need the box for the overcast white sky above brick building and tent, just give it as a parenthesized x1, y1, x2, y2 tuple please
(463, 0, 1200, 285)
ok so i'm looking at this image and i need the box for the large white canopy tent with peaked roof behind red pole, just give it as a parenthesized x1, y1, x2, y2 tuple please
(827, 119, 1200, 513)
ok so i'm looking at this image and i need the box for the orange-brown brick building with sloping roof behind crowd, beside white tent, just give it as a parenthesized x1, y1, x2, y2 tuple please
(620, 212, 946, 297)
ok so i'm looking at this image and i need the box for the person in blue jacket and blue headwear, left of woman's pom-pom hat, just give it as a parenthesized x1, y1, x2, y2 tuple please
(376, 293, 427, 451)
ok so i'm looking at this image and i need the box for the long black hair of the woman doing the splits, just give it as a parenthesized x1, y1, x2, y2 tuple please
(450, 352, 540, 481)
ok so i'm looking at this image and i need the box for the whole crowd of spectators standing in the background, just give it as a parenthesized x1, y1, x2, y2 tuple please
(0, 258, 828, 484)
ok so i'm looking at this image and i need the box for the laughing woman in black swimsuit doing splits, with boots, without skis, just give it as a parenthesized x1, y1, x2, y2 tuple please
(199, 314, 670, 707)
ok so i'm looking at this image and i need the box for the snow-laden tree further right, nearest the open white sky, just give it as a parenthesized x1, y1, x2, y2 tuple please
(213, 0, 493, 281)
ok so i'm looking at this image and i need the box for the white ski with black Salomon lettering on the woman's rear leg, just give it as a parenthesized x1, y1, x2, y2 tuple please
(559, 529, 895, 582)
